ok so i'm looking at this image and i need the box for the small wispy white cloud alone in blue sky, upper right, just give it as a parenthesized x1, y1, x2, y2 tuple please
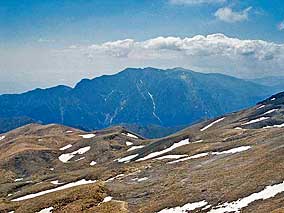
(214, 7, 252, 23)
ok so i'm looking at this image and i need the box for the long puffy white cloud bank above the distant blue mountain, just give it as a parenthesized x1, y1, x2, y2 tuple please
(86, 34, 284, 61)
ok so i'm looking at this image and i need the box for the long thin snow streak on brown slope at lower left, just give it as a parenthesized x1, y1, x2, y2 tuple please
(12, 179, 96, 201)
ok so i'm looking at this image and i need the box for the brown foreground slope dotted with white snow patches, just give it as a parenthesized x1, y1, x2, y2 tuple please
(0, 93, 284, 213)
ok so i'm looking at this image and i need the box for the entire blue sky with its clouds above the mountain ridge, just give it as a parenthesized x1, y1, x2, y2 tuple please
(0, 0, 284, 94)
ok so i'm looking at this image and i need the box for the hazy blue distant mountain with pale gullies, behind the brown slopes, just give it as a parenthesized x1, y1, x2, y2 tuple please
(0, 68, 275, 136)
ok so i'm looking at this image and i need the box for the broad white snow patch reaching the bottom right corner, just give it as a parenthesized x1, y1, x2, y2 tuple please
(209, 181, 284, 213)
